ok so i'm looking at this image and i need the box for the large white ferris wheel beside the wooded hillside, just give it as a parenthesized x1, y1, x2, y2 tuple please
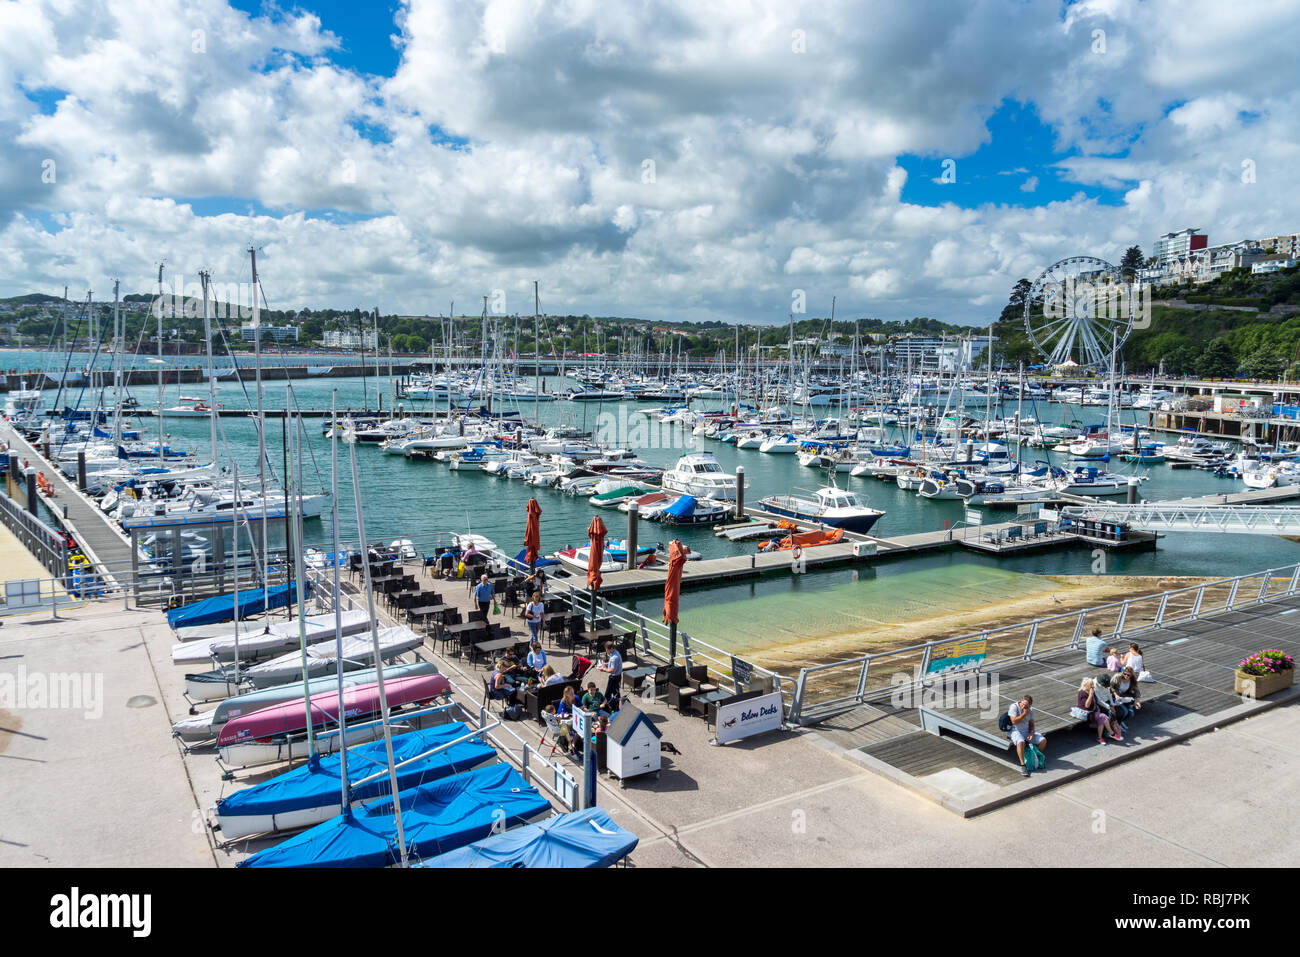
(1024, 256, 1135, 367)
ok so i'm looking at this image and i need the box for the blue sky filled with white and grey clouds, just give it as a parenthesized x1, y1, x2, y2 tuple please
(0, 0, 1300, 326)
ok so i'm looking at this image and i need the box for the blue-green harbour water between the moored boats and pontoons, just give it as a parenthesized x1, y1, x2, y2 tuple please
(12, 355, 1300, 648)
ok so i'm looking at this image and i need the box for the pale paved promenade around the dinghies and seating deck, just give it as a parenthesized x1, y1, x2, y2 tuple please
(0, 590, 1300, 867)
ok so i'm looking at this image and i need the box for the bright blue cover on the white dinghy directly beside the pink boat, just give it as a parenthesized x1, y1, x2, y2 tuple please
(217, 722, 497, 817)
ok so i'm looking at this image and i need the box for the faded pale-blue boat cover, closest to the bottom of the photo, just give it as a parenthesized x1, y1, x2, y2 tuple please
(419, 807, 637, 867)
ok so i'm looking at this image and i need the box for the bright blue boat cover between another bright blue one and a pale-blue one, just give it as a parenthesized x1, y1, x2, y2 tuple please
(239, 765, 551, 867)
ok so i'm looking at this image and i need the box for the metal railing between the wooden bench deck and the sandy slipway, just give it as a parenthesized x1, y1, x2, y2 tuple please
(789, 563, 1300, 724)
